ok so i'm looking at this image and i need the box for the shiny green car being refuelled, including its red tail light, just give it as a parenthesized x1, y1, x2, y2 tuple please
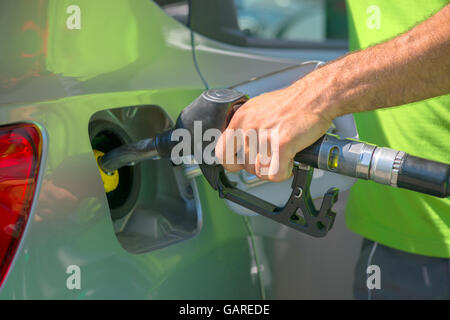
(0, 0, 357, 299)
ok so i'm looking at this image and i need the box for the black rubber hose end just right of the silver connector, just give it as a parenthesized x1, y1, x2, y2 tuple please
(397, 154, 450, 198)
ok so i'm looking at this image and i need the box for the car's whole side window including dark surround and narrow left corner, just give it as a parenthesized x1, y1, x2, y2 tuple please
(155, 0, 347, 49)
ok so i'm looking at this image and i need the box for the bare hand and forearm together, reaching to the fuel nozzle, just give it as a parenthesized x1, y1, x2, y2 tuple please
(215, 5, 450, 181)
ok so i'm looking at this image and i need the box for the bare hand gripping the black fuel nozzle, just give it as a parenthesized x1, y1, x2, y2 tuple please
(215, 71, 332, 182)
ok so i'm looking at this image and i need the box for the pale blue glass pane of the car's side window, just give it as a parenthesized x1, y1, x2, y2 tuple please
(234, 0, 347, 42)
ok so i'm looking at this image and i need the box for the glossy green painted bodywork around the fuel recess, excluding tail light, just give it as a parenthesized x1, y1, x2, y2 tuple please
(0, 0, 348, 299)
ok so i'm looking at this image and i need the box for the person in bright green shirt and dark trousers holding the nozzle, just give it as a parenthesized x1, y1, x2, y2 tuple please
(215, 0, 450, 299)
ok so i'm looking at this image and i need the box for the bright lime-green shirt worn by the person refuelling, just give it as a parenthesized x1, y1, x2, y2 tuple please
(346, 0, 450, 258)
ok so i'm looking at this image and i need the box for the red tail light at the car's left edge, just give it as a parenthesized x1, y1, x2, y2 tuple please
(0, 124, 42, 286)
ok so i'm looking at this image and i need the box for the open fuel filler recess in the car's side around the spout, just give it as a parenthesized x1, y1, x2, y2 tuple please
(89, 105, 202, 254)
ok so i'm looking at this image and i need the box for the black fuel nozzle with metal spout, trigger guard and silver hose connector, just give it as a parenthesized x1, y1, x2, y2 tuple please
(96, 89, 450, 237)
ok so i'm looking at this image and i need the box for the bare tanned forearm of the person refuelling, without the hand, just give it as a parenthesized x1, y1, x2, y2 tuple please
(293, 5, 450, 119)
